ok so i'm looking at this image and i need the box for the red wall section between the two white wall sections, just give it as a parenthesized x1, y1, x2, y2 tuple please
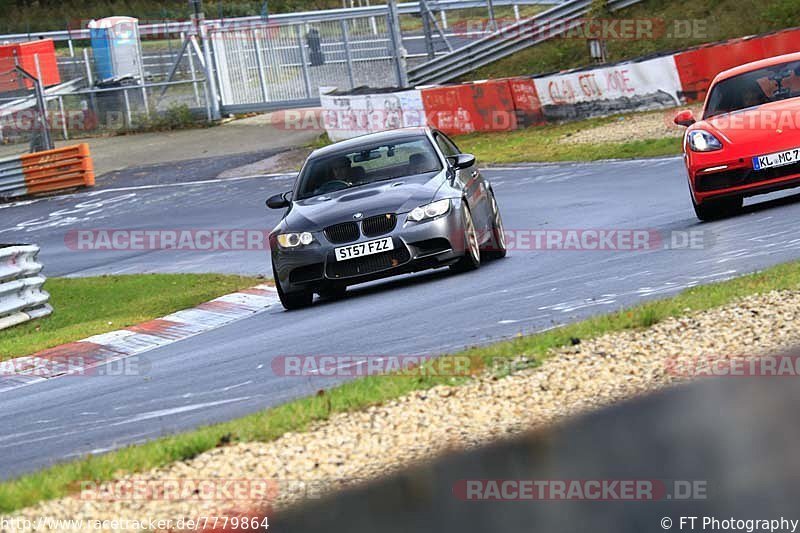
(422, 80, 517, 135)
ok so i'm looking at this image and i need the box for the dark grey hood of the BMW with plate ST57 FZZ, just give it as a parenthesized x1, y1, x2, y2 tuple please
(284, 171, 446, 231)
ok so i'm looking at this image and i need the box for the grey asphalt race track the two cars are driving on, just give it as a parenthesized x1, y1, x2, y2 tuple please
(0, 158, 800, 478)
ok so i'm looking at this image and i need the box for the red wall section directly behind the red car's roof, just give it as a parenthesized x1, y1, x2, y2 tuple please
(675, 28, 800, 102)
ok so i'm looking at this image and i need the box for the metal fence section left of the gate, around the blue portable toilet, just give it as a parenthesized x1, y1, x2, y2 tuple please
(0, 37, 211, 147)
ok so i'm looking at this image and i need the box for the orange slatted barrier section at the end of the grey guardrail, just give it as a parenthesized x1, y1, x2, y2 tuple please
(20, 143, 94, 194)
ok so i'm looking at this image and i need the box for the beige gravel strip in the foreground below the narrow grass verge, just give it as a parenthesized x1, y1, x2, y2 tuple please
(6, 291, 800, 520)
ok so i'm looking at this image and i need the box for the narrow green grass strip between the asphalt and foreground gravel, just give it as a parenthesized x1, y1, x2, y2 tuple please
(0, 262, 800, 512)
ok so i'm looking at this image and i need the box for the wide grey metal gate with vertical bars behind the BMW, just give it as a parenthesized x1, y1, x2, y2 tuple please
(209, 15, 402, 113)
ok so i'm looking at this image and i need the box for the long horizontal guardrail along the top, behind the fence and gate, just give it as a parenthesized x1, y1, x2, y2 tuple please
(0, 0, 562, 42)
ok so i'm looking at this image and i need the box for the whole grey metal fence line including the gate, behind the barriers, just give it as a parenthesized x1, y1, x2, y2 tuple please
(0, 0, 568, 145)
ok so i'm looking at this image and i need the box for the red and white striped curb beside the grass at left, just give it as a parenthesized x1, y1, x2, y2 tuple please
(0, 285, 279, 392)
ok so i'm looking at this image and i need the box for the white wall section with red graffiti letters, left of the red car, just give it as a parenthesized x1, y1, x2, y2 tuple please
(534, 56, 681, 111)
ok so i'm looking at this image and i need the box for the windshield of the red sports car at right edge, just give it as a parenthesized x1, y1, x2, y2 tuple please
(703, 61, 800, 118)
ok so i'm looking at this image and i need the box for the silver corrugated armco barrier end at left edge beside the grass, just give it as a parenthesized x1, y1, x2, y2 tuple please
(0, 244, 53, 329)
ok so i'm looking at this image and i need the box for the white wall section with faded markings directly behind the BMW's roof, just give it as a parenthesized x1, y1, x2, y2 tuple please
(320, 89, 427, 141)
